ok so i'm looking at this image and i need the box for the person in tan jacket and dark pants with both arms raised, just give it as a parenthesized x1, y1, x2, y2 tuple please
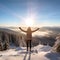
(19, 27, 39, 51)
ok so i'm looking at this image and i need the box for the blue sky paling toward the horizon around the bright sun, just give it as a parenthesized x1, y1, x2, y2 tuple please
(0, 0, 60, 26)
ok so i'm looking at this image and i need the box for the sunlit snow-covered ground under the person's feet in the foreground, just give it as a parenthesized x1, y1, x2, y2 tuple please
(0, 45, 60, 60)
